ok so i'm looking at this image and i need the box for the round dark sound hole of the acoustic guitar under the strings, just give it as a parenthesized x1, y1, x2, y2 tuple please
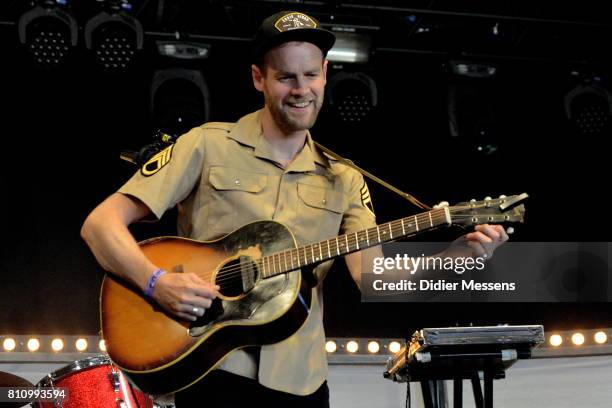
(215, 256, 259, 297)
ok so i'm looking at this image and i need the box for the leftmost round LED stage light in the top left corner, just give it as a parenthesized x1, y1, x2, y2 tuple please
(18, 0, 78, 68)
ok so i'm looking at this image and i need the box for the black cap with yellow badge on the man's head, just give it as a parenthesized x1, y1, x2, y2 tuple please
(253, 11, 336, 60)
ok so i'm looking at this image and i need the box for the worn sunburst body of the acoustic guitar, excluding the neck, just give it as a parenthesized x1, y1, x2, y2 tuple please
(100, 221, 311, 395)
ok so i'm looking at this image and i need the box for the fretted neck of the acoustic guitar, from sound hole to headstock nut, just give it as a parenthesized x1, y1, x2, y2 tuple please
(258, 207, 451, 278)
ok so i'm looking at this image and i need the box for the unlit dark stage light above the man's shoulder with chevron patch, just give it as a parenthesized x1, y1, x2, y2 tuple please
(150, 68, 210, 136)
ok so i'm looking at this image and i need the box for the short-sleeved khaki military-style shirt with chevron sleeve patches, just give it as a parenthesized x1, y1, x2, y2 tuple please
(119, 111, 375, 395)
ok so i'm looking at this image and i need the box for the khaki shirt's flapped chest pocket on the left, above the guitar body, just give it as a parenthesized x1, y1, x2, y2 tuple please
(206, 166, 268, 233)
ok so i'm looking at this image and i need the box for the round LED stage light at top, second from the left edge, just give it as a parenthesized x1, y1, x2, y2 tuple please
(85, 0, 144, 72)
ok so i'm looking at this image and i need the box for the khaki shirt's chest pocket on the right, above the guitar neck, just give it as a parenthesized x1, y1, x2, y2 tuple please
(297, 183, 345, 243)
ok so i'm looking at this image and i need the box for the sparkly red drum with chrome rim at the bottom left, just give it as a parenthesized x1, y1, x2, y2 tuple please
(33, 355, 154, 408)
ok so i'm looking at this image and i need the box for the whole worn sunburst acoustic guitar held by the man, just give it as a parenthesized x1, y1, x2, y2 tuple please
(100, 193, 527, 395)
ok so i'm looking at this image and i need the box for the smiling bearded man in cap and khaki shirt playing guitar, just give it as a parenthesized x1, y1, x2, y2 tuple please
(82, 12, 508, 408)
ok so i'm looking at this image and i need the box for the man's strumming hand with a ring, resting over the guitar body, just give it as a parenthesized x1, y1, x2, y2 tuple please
(153, 273, 219, 321)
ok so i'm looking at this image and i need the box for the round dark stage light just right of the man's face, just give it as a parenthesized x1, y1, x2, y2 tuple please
(328, 72, 378, 123)
